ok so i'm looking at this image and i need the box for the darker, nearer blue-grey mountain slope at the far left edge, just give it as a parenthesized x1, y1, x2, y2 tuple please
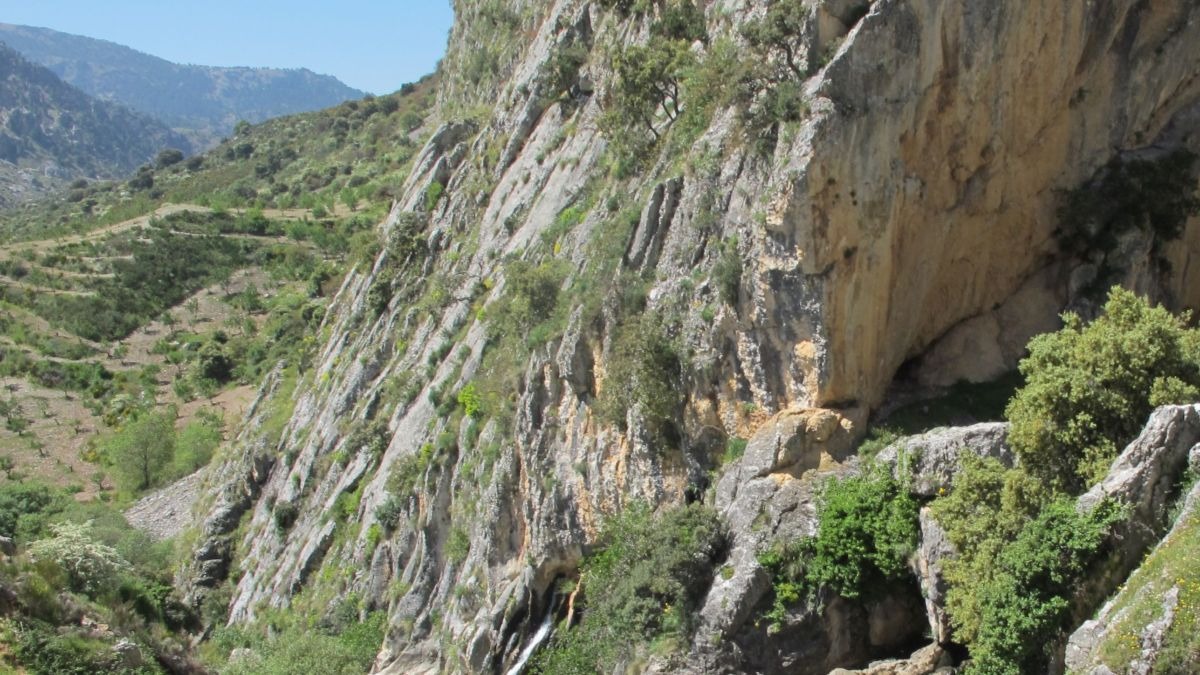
(0, 44, 192, 207)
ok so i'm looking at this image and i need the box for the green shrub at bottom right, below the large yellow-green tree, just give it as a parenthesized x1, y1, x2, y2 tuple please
(932, 455, 1122, 674)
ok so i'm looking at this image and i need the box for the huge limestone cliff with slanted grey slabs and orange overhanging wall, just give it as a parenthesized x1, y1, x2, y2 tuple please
(177, 0, 1200, 673)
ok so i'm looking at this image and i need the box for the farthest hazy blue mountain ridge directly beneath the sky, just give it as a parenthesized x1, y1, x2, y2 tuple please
(0, 24, 366, 149)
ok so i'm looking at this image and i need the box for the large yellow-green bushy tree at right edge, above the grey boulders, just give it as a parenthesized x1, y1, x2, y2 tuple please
(1007, 288, 1200, 491)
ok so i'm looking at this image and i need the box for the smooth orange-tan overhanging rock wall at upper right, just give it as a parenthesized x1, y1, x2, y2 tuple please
(801, 0, 1200, 404)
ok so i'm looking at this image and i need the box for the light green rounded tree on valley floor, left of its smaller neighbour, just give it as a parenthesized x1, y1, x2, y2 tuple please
(102, 407, 175, 492)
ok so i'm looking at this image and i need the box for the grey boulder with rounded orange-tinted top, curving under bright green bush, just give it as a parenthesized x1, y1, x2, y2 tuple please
(689, 410, 924, 674)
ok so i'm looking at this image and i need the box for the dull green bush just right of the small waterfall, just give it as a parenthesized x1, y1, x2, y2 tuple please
(533, 504, 726, 675)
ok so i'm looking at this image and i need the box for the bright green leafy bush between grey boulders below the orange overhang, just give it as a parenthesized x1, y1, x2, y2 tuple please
(760, 465, 919, 626)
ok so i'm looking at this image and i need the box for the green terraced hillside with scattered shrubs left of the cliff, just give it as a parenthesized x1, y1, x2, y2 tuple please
(0, 82, 431, 500)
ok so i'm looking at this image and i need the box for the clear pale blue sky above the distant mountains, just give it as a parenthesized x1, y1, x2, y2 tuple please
(0, 0, 454, 94)
